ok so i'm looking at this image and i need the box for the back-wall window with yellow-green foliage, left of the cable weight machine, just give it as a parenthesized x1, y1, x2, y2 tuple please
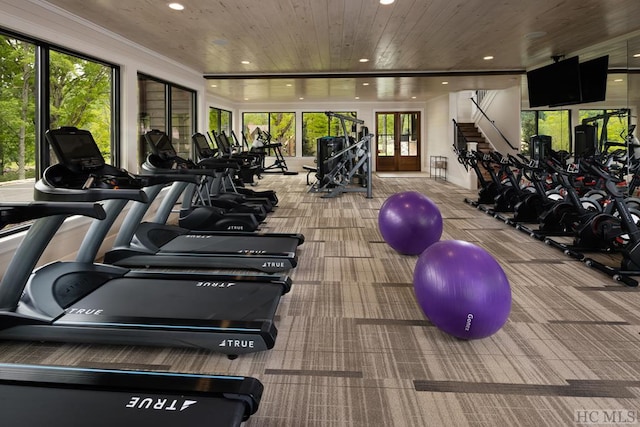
(244, 113, 296, 157)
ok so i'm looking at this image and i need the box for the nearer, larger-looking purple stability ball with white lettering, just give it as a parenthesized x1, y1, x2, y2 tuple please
(413, 240, 511, 340)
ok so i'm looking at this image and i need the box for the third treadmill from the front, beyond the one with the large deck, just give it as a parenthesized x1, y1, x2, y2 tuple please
(102, 132, 304, 273)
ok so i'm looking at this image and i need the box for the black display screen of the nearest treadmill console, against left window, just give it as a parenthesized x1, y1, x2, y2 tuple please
(49, 131, 105, 169)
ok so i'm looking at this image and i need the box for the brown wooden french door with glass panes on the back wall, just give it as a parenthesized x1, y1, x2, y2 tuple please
(375, 111, 420, 172)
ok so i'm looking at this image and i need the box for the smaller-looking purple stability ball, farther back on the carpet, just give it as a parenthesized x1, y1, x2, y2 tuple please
(378, 191, 442, 255)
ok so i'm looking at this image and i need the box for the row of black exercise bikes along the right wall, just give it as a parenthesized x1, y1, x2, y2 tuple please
(456, 127, 640, 287)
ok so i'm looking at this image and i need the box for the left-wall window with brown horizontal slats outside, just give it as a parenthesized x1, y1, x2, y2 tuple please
(138, 74, 196, 163)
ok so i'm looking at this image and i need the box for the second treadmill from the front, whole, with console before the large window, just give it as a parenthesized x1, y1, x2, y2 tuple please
(0, 128, 291, 358)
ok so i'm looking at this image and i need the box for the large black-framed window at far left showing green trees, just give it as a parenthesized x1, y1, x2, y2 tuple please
(0, 33, 119, 214)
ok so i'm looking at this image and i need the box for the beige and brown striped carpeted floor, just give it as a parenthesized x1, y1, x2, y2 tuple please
(0, 174, 640, 427)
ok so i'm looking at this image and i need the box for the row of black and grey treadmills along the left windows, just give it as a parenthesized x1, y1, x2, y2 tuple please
(0, 127, 304, 426)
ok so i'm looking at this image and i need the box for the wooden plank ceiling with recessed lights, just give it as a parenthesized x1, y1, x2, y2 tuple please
(42, 0, 640, 102)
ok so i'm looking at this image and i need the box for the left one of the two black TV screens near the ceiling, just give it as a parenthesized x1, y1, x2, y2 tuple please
(527, 56, 582, 107)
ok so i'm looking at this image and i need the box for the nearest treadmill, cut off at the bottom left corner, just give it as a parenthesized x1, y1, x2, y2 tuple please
(0, 206, 263, 427)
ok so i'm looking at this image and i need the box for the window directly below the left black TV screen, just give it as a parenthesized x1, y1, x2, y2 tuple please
(520, 110, 572, 153)
